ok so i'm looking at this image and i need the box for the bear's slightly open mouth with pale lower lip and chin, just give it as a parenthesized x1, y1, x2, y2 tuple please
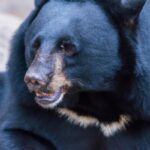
(35, 87, 65, 108)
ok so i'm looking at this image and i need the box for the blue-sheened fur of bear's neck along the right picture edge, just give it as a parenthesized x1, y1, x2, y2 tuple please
(122, 17, 150, 120)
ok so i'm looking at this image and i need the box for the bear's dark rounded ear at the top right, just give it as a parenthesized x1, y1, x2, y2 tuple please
(107, 0, 146, 26)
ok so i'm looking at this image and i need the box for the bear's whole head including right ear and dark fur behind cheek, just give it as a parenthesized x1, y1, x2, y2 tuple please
(24, 0, 145, 120)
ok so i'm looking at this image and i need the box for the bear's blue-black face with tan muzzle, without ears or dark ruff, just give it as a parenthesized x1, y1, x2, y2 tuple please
(25, 1, 121, 108)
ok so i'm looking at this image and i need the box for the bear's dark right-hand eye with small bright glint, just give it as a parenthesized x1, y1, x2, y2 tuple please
(60, 40, 77, 56)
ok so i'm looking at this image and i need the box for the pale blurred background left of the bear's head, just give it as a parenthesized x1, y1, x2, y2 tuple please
(0, 0, 34, 71)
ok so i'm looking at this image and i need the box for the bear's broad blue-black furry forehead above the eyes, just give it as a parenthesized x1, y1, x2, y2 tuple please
(26, 0, 116, 47)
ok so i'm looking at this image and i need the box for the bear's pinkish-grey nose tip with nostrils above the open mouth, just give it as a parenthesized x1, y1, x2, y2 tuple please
(24, 73, 46, 92)
